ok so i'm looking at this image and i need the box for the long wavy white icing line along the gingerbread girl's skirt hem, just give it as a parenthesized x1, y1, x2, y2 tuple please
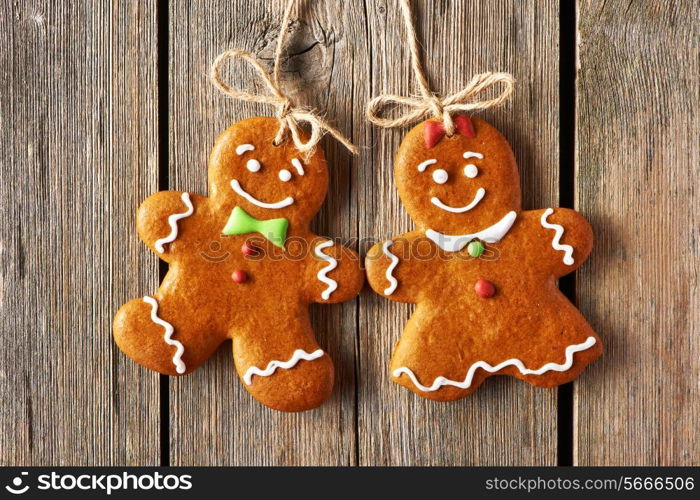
(393, 337, 596, 392)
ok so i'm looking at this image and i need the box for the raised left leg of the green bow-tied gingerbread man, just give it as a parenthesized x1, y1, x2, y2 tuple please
(113, 295, 224, 375)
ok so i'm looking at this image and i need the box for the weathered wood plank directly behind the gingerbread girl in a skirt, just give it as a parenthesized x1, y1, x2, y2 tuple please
(357, 0, 559, 465)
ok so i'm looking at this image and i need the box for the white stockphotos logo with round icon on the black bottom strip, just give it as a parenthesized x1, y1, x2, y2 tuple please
(5, 472, 192, 495)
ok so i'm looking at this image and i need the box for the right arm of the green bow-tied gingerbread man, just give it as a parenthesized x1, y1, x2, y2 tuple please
(305, 237, 365, 304)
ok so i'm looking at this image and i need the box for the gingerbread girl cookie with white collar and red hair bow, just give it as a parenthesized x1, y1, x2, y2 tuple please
(366, 115, 602, 401)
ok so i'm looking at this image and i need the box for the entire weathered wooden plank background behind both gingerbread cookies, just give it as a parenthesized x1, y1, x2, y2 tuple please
(0, 0, 700, 465)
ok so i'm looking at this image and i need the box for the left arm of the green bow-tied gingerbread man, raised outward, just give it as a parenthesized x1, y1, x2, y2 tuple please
(136, 191, 202, 262)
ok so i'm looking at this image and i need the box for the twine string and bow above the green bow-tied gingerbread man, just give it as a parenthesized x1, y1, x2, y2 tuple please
(209, 0, 357, 156)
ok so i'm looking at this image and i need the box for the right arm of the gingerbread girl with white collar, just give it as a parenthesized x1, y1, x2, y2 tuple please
(523, 208, 593, 278)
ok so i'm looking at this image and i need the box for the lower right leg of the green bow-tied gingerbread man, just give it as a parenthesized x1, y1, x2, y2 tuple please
(233, 310, 334, 412)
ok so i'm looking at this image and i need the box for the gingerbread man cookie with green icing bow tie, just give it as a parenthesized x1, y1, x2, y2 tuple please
(114, 118, 364, 411)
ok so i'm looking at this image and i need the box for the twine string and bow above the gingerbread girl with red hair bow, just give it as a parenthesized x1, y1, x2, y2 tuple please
(367, 0, 515, 136)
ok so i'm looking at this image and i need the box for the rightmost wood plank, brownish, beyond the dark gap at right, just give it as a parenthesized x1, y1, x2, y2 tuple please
(575, 0, 700, 465)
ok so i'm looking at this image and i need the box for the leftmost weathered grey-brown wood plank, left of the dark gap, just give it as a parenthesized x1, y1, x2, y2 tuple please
(0, 1, 160, 465)
